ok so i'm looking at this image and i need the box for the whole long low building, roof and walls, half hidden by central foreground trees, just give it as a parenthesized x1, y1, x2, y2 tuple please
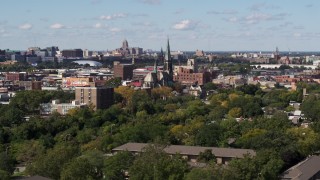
(112, 143, 256, 164)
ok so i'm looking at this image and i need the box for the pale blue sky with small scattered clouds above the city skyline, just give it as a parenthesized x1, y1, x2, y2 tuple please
(0, 0, 320, 51)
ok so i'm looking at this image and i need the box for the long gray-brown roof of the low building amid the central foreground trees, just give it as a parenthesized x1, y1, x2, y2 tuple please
(112, 143, 256, 158)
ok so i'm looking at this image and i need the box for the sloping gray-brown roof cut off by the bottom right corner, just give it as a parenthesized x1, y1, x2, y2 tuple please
(281, 156, 320, 180)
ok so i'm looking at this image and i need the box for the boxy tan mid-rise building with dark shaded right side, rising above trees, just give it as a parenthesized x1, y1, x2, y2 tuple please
(76, 86, 113, 110)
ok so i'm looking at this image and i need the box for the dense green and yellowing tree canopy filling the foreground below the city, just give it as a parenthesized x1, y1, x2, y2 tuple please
(0, 85, 320, 179)
